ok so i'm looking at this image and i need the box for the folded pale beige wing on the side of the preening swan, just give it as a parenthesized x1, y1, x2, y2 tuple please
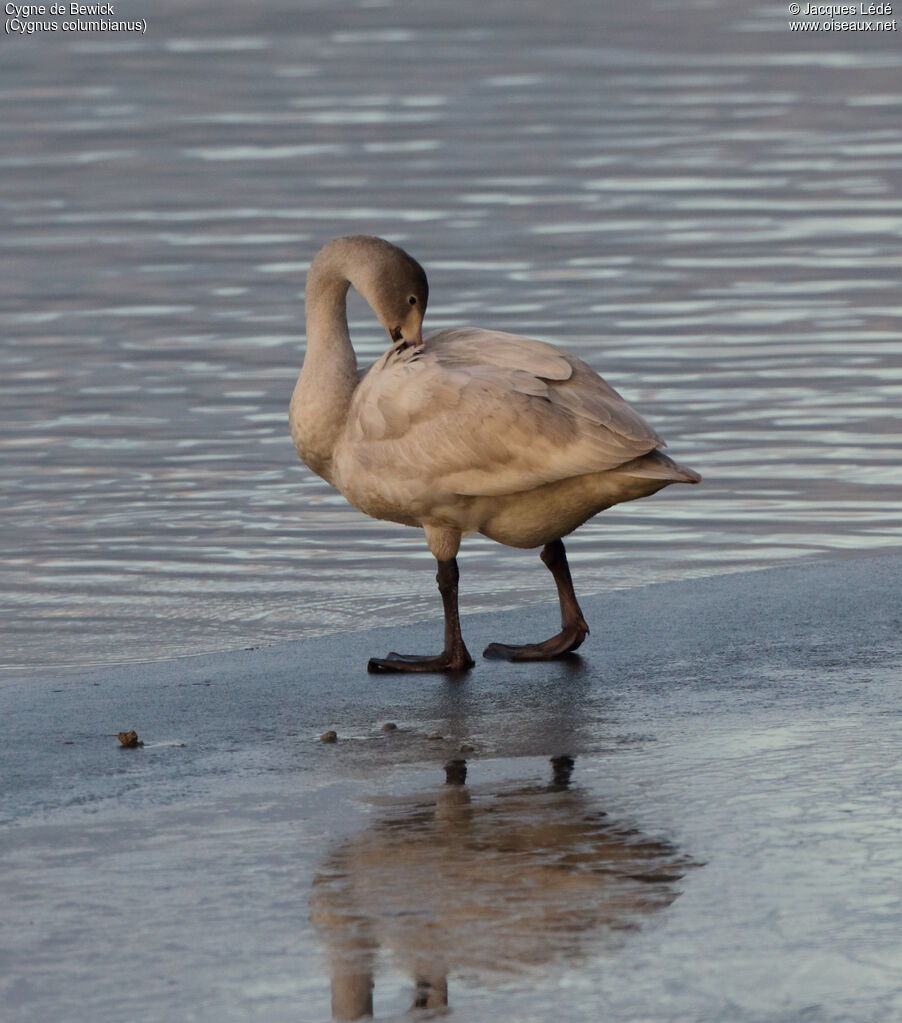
(345, 328, 662, 495)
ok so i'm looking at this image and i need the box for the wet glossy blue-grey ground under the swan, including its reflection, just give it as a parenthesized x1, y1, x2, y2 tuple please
(0, 554, 902, 1023)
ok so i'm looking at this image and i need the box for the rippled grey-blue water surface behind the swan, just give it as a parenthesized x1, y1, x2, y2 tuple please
(0, 0, 902, 665)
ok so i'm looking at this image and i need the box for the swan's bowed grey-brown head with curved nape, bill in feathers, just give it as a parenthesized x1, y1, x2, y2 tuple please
(314, 234, 430, 347)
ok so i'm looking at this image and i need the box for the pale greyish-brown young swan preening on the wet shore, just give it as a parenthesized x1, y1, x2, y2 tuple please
(288, 235, 702, 672)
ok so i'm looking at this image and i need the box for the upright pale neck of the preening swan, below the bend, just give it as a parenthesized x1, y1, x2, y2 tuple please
(288, 253, 357, 483)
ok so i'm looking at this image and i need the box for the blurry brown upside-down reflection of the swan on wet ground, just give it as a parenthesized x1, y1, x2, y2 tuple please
(311, 757, 692, 1020)
